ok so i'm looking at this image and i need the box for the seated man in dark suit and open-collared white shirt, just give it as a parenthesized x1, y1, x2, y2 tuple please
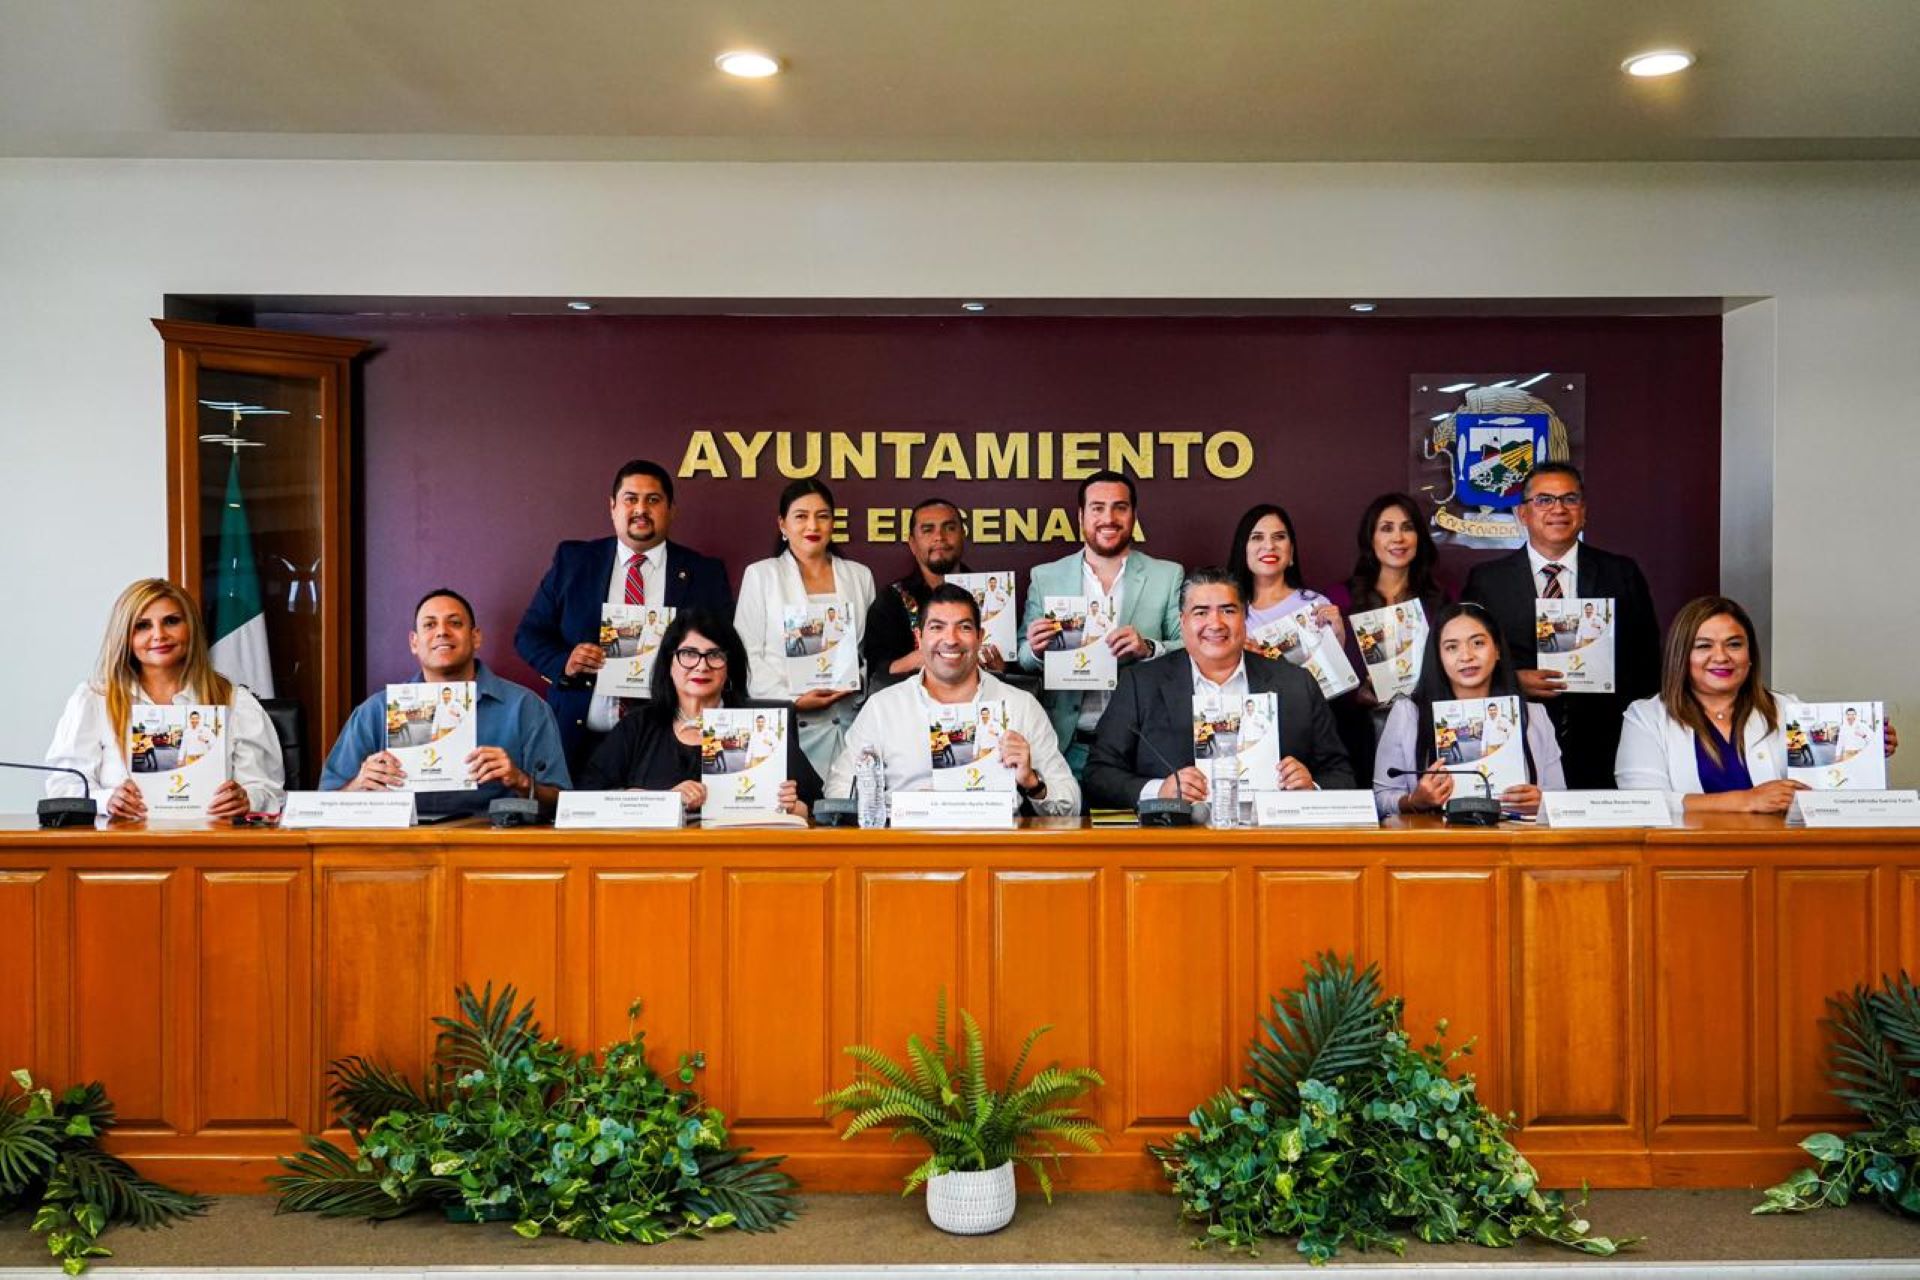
(1085, 568, 1354, 810)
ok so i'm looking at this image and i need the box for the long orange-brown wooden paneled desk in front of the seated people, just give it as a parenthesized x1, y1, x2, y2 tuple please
(0, 818, 1920, 1190)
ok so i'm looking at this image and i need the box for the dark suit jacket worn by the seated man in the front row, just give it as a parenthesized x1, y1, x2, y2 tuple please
(1083, 649, 1354, 810)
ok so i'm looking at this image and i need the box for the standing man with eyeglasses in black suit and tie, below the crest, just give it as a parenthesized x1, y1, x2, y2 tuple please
(1461, 462, 1661, 791)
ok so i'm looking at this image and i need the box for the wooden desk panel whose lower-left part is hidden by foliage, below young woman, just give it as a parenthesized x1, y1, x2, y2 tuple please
(1386, 869, 1511, 1111)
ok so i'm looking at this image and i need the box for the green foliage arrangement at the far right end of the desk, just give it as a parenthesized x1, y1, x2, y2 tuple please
(1753, 971, 1920, 1217)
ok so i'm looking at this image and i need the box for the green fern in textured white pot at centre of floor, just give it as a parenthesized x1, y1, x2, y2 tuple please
(820, 990, 1104, 1236)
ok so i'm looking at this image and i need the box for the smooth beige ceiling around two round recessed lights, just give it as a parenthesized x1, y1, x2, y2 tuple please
(0, 0, 1920, 161)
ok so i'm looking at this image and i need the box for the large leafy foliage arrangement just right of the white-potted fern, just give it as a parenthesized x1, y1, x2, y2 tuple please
(1152, 956, 1632, 1263)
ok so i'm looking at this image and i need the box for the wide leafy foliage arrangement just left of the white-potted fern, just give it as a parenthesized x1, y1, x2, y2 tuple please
(269, 984, 793, 1244)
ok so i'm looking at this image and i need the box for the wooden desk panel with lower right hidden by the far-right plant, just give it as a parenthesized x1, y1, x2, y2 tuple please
(1772, 867, 1880, 1125)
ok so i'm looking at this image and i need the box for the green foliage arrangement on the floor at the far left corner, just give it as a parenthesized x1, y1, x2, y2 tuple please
(0, 1071, 207, 1276)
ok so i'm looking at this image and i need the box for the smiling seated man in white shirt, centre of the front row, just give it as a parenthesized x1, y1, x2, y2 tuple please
(826, 583, 1081, 818)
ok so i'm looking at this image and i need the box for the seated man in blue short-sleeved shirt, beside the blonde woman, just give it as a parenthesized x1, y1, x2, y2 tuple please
(321, 587, 572, 816)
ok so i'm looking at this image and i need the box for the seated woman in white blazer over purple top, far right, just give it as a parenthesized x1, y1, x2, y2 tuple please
(1613, 595, 1899, 814)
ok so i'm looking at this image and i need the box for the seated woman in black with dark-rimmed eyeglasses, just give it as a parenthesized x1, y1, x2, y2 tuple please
(580, 608, 820, 818)
